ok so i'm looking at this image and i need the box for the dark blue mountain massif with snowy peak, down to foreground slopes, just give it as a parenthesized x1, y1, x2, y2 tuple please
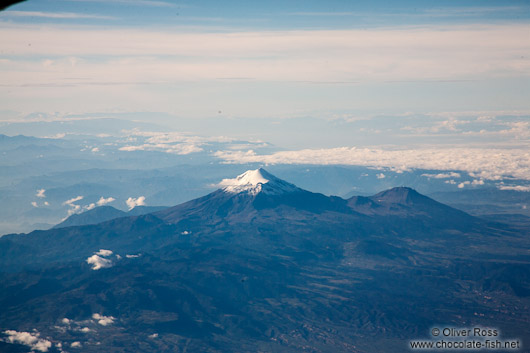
(0, 169, 530, 352)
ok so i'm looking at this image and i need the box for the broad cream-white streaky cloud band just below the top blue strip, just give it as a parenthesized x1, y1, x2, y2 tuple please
(0, 25, 530, 85)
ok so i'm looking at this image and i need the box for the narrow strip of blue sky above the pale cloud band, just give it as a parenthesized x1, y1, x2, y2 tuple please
(4, 0, 530, 29)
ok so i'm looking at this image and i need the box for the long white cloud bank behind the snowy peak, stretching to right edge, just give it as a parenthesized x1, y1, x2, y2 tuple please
(214, 147, 530, 180)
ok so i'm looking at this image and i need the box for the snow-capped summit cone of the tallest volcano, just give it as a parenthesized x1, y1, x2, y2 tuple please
(219, 168, 300, 195)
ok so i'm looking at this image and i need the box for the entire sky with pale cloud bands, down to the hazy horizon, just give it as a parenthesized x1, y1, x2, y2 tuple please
(0, 0, 530, 148)
